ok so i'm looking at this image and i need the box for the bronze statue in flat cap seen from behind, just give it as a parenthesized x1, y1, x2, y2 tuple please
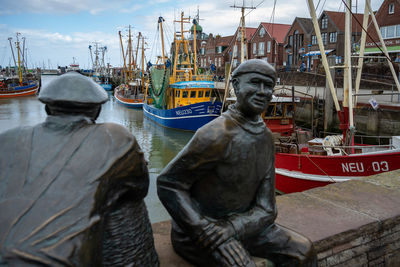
(0, 73, 158, 266)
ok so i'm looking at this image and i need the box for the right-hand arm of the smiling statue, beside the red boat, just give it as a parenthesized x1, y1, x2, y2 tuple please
(229, 138, 277, 239)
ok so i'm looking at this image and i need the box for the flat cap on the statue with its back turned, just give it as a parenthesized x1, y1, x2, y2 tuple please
(39, 72, 108, 106)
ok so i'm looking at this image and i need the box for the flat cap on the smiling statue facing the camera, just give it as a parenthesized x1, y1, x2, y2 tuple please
(232, 59, 276, 81)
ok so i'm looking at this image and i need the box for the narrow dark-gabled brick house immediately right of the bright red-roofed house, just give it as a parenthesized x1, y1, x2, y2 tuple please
(283, 17, 314, 70)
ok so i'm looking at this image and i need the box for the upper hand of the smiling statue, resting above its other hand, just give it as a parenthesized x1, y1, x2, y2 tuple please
(198, 222, 236, 251)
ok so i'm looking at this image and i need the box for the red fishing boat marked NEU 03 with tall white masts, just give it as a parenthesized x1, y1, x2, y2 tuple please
(275, 0, 400, 193)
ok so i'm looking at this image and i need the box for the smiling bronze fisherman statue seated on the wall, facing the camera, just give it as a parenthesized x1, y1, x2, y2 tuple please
(157, 59, 316, 266)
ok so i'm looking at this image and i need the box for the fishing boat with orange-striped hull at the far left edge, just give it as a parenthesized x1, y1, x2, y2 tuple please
(0, 33, 40, 98)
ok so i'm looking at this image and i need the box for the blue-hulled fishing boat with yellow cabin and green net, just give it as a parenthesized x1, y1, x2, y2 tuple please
(143, 12, 222, 131)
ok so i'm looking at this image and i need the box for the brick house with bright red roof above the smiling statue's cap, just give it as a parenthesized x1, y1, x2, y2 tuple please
(250, 22, 290, 67)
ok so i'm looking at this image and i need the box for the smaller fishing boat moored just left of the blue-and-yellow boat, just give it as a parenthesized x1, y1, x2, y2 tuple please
(114, 26, 145, 109)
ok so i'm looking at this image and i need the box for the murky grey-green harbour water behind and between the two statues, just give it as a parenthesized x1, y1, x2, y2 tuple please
(0, 76, 193, 222)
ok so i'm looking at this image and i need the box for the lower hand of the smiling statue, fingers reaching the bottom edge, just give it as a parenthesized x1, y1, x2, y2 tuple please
(213, 239, 256, 267)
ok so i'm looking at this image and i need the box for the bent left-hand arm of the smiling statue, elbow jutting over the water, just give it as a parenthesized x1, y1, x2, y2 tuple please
(157, 128, 224, 240)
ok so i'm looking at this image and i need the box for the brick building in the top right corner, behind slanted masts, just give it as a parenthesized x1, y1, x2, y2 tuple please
(365, 0, 400, 62)
